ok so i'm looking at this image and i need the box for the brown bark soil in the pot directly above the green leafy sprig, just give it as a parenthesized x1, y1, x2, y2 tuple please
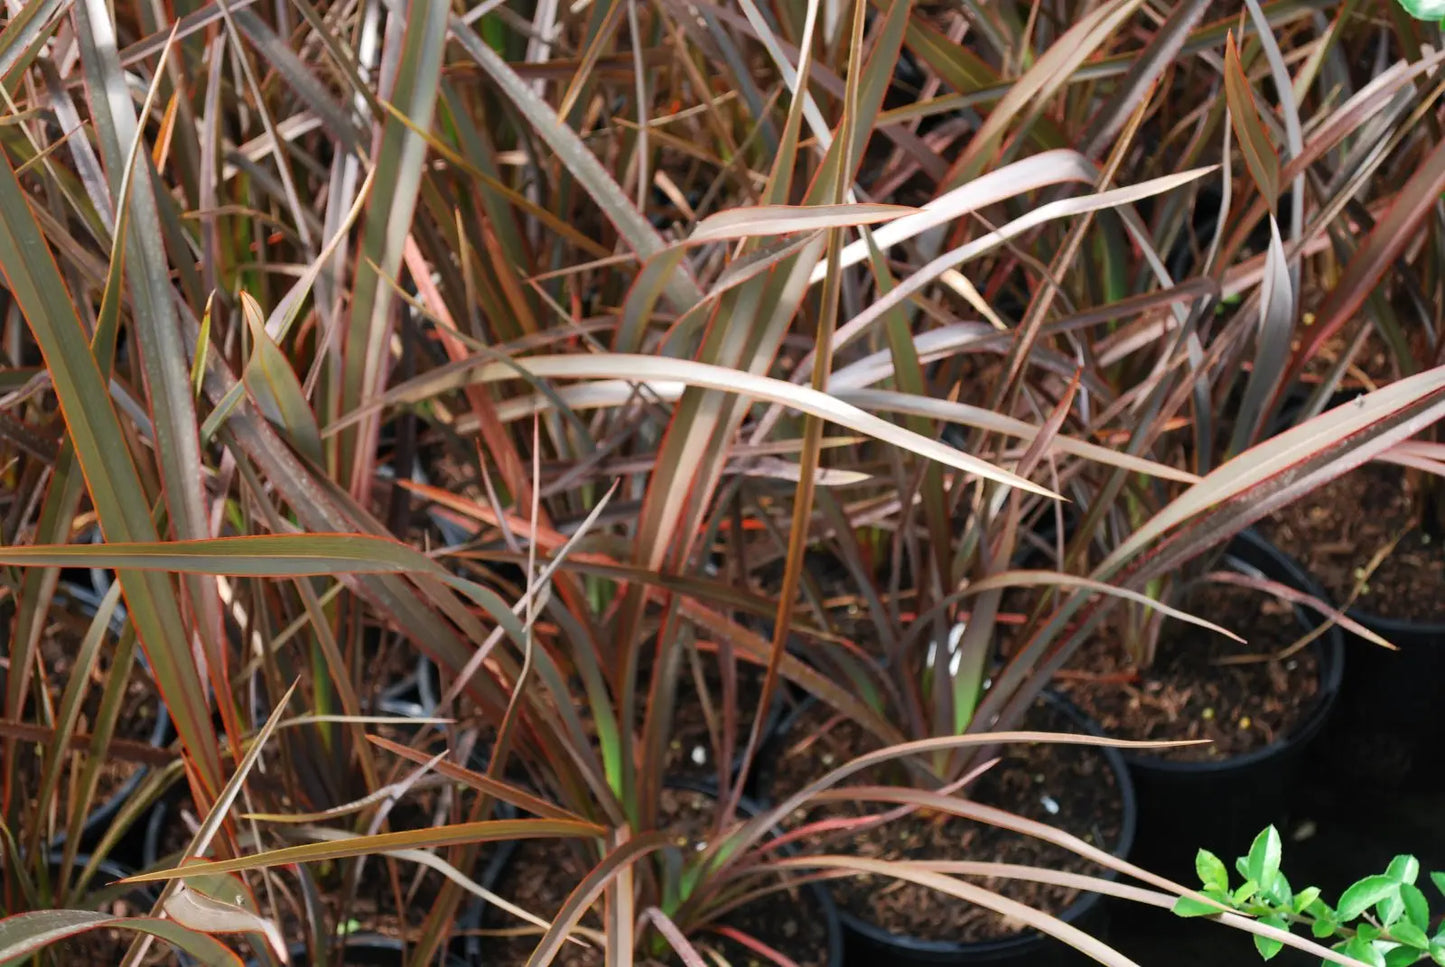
(1059, 584, 1319, 762)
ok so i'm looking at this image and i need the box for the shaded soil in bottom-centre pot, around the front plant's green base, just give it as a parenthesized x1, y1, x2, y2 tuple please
(481, 789, 828, 967)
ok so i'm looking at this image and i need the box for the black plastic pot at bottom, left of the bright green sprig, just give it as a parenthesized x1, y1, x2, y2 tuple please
(777, 692, 1139, 967)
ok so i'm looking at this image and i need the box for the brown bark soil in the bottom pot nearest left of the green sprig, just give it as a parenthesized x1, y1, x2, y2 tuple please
(764, 704, 1123, 942)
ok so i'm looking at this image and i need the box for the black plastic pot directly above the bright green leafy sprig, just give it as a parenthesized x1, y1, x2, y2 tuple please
(1124, 530, 1345, 883)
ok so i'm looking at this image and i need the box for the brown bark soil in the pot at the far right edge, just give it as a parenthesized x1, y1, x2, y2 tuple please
(1260, 464, 1445, 622)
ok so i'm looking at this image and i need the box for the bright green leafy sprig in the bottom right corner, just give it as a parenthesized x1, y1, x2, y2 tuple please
(1173, 827, 1445, 967)
